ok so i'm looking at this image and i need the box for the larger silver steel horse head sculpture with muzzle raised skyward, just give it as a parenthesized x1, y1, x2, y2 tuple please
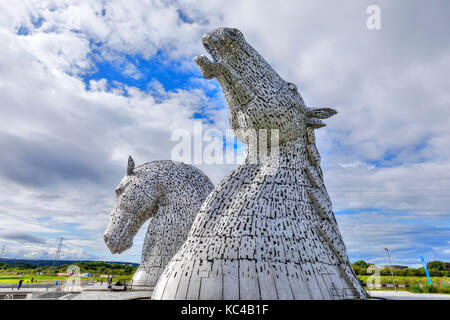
(152, 28, 367, 299)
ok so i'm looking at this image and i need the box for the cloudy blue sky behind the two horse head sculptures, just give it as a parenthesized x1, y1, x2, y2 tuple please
(0, 0, 450, 265)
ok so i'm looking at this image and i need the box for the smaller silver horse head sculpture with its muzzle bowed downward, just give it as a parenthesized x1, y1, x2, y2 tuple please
(104, 157, 214, 286)
